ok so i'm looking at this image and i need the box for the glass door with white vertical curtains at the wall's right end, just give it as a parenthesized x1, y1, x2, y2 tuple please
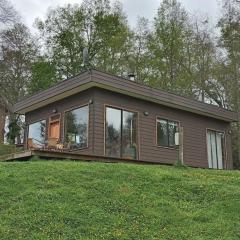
(207, 130, 224, 169)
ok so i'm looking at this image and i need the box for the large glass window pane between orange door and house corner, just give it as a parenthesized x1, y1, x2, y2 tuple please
(65, 105, 89, 149)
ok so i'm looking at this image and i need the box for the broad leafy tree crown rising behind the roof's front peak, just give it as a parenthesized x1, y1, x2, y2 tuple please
(36, 0, 131, 79)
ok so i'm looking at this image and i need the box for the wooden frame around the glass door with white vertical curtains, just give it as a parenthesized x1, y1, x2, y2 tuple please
(205, 128, 228, 170)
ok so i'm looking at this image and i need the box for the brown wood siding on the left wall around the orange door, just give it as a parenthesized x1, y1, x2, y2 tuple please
(26, 90, 93, 154)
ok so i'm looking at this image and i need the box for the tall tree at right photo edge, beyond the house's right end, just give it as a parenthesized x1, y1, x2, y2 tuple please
(218, 0, 240, 166)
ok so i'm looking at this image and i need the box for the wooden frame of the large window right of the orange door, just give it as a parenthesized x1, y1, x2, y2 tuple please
(63, 103, 90, 152)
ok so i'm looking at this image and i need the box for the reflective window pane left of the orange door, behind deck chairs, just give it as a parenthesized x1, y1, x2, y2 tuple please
(28, 120, 46, 148)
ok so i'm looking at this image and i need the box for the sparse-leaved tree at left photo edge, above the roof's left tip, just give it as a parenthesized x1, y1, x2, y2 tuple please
(0, 23, 37, 103)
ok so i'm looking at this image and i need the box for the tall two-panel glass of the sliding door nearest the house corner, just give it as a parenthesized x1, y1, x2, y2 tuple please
(105, 107, 137, 159)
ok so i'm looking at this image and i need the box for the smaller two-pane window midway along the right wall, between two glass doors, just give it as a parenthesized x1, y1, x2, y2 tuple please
(157, 119, 178, 147)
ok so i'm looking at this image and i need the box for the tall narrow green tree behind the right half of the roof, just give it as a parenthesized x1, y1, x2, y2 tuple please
(146, 0, 192, 95)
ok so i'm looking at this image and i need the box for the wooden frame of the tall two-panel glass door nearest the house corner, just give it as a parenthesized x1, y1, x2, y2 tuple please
(103, 104, 140, 161)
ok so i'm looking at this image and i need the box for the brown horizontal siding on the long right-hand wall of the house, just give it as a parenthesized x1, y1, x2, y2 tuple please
(93, 89, 232, 169)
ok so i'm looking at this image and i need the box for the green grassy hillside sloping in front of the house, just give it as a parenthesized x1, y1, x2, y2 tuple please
(0, 161, 240, 240)
